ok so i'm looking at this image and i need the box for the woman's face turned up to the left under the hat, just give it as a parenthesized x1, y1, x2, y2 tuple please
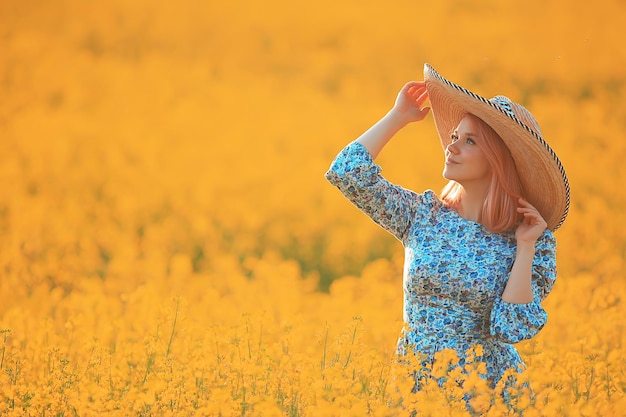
(443, 115, 491, 188)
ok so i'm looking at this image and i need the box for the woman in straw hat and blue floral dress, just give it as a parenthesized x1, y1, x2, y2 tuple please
(326, 64, 569, 389)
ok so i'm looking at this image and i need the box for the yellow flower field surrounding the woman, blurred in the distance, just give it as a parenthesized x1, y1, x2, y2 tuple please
(0, 0, 626, 417)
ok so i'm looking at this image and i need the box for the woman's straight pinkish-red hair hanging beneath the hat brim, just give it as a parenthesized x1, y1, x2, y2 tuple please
(441, 114, 524, 233)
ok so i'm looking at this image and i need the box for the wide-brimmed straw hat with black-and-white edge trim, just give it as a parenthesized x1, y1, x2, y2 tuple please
(424, 64, 570, 231)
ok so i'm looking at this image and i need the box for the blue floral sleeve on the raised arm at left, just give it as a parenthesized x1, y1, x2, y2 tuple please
(325, 142, 420, 241)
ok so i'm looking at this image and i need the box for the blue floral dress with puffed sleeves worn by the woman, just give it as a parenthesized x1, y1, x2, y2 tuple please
(326, 142, 556, 385)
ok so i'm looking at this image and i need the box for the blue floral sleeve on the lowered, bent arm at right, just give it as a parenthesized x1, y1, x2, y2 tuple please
(490, 230, 556, 343)
